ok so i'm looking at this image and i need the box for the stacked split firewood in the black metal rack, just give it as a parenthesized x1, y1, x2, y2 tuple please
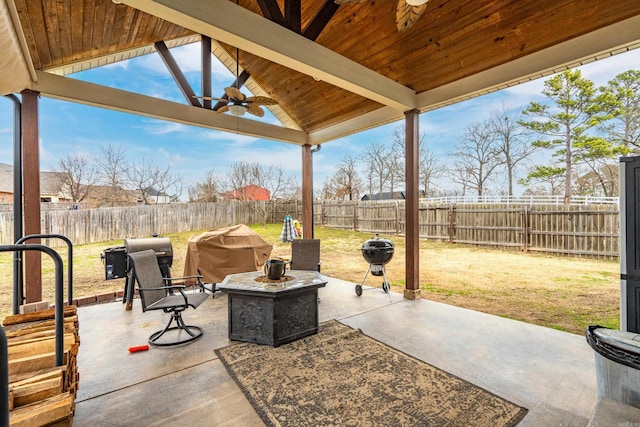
(2, 306, 80, 427)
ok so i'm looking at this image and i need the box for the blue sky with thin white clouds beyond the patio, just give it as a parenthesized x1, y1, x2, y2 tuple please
(0, 43, 640, 197)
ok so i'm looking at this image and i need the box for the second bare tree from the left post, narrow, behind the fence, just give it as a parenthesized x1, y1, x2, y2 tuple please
(96, 144, 130, 206)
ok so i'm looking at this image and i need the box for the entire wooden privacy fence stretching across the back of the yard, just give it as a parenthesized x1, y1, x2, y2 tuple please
(0, 200, 619, 258)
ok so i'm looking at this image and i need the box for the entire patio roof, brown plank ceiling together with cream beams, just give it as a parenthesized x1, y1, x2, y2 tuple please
(0, 0, 640, 145)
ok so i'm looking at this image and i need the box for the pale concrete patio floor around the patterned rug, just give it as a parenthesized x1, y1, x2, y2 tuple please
(74, 279, 624, 427)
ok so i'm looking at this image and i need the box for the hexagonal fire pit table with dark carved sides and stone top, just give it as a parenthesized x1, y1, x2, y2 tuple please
(218, 270, 327, 347)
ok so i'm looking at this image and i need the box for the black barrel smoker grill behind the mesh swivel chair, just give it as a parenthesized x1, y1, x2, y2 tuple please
(101, 237, 173, 310)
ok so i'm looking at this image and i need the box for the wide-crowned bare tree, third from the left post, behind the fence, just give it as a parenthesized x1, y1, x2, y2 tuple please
(125, 157, 182, 205)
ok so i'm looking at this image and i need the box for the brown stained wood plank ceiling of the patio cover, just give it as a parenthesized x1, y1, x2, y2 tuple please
(15, 0, 640, 132)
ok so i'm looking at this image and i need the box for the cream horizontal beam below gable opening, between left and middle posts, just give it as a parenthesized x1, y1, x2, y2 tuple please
(31, 71, 308, 145)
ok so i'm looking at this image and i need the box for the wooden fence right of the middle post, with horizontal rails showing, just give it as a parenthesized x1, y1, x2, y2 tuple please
(314, 201, 620, 258)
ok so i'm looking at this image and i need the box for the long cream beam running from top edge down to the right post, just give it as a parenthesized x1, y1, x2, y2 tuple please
(122, 0, 416, 111)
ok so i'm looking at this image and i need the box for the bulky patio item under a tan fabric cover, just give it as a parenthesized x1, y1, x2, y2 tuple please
(184, 224, 273, 283)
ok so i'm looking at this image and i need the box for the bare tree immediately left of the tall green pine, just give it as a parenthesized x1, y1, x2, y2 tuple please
(488, 105, 538, 196)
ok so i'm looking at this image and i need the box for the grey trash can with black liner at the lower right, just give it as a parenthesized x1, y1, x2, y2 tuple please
(587, 325, 640, 409)
